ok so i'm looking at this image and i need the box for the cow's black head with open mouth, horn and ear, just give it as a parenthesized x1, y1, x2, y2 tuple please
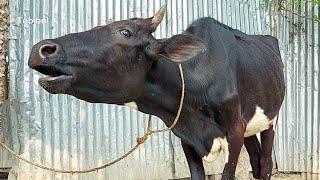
(28, 6, 205, 103)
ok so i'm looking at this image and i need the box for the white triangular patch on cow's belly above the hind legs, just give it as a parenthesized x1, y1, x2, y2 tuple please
(244, 106, 276, 137)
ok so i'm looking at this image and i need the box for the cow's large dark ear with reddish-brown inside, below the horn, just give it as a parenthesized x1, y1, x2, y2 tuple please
(158, 34, 206, 63)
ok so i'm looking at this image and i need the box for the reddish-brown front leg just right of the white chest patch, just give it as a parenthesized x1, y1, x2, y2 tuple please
(222, 122, 244, 180)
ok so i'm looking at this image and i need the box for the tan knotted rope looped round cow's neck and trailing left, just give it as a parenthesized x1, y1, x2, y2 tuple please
(0, 64, 185, 174)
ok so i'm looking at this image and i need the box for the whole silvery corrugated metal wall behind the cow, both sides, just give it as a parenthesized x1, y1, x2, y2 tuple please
(0, 0, 320, 179)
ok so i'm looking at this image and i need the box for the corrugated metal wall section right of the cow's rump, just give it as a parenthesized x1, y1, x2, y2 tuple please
(275, 2, 320, 179)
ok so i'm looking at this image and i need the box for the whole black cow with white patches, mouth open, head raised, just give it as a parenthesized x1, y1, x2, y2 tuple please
(28, 7, 285, 179)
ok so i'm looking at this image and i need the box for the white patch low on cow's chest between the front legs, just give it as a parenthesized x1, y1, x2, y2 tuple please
(202, 137, 229, 162)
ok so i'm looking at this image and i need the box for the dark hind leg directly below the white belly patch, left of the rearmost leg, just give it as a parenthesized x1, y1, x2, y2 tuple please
(244, 135, 261, 179)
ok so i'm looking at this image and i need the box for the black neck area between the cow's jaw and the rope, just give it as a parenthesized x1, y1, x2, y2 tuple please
(136, 60, 183, 126)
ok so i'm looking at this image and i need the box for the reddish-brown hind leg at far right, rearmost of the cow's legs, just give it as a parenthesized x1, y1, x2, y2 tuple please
(260, 126, 274, 180)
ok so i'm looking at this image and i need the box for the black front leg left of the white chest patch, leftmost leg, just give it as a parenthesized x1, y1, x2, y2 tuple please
(181, 141, 205, 180)
